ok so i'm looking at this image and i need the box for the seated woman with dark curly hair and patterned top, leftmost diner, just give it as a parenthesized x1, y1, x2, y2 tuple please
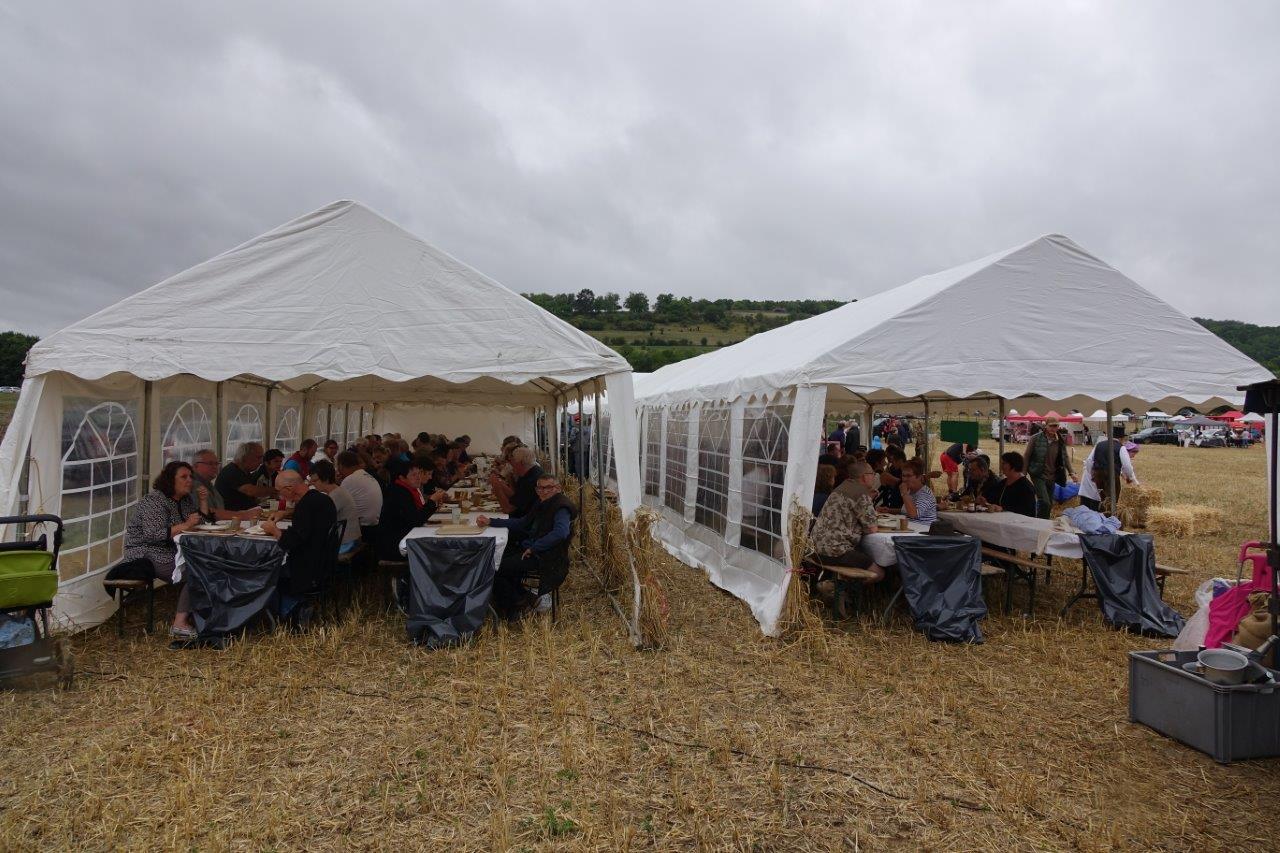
(123, 461, 214, 639)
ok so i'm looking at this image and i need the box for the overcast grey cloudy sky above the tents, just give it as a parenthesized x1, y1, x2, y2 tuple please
(0, 0, 1280, 334)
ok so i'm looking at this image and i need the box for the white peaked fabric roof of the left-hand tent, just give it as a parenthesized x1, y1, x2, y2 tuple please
(27, 201, 630, 384)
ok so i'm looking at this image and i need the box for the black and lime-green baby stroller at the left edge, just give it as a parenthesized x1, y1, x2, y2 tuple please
(0, 515, 74, 686)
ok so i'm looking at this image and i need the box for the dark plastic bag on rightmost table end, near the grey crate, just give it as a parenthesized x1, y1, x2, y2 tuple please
(1080, 533, 1185, 637)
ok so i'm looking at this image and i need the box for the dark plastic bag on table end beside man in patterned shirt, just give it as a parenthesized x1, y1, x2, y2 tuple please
(893, 535, 987, 643)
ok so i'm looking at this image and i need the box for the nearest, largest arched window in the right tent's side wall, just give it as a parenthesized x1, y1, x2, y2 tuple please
(740, 403, 791, 560)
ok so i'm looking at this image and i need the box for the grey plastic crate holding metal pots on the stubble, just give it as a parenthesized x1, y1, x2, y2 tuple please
(1129, 651, 1280, 763)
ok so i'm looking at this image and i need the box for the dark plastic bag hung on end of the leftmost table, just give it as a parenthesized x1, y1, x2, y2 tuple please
(180, 537, 284, 639)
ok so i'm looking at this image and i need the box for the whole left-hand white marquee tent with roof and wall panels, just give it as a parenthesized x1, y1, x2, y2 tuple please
(0, 201, 640, 625)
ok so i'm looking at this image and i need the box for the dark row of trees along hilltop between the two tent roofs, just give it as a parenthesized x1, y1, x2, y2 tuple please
(524, 288, 847, 332)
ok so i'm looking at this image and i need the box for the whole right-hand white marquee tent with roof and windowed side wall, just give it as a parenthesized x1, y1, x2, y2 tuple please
(629, 236, 1270, 633)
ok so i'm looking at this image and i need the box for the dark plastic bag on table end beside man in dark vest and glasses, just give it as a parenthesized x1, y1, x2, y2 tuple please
(406, 537, 495, 648)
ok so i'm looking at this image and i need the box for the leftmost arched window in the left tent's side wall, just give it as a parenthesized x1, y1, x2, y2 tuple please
(58, 398, 138, 580)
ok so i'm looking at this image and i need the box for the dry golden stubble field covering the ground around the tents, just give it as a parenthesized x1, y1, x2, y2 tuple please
(0, 447, 1280, 850)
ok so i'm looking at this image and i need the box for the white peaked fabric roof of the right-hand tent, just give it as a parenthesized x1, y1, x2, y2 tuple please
(645, 234, 1270, 402)
